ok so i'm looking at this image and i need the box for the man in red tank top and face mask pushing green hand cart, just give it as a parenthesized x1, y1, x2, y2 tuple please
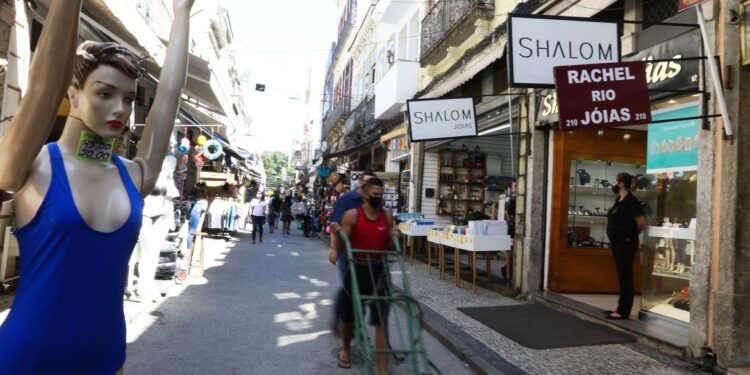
(328, 177, 394, 375)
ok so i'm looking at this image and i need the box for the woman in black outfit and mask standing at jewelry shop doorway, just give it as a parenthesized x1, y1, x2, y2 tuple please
(604, 173, 646, 319)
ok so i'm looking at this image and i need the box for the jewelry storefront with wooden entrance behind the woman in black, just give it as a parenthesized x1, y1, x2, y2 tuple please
(536, 29, 705, 326)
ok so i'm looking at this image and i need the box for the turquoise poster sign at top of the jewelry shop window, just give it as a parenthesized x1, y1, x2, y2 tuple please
(646, 104, 701, 174)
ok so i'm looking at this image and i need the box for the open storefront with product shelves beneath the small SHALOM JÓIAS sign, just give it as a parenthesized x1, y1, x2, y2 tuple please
(418, 96, 519, 224)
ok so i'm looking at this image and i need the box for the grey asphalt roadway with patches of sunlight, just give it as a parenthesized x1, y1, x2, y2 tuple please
(125, 230, 473, 374)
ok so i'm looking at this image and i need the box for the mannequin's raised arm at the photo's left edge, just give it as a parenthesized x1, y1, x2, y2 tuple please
(0, 0, 83, 192)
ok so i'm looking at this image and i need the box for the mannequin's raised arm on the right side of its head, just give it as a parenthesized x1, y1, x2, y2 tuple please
(134, 0, 194, 197)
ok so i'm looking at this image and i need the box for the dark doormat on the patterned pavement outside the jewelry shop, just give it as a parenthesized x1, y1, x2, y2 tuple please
(458, 304, 636, 349)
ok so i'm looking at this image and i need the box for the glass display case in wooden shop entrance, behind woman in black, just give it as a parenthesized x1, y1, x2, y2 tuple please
(568, 159, 653, 249)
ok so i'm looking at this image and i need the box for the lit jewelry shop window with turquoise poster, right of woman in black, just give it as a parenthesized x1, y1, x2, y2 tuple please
(641, 103, 700, 322)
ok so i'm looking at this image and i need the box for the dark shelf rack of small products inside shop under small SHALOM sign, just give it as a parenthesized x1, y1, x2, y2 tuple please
(436, 150, 487, 221)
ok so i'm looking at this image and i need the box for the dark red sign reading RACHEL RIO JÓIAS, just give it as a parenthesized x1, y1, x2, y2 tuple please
(554, 61, 651, 130)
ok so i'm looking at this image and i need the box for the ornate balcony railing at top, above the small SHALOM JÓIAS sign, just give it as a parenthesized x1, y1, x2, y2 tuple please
(420, 0, 494, 59)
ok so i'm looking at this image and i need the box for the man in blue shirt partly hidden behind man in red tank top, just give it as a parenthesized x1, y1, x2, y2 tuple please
(328, 171, 377, 333)
